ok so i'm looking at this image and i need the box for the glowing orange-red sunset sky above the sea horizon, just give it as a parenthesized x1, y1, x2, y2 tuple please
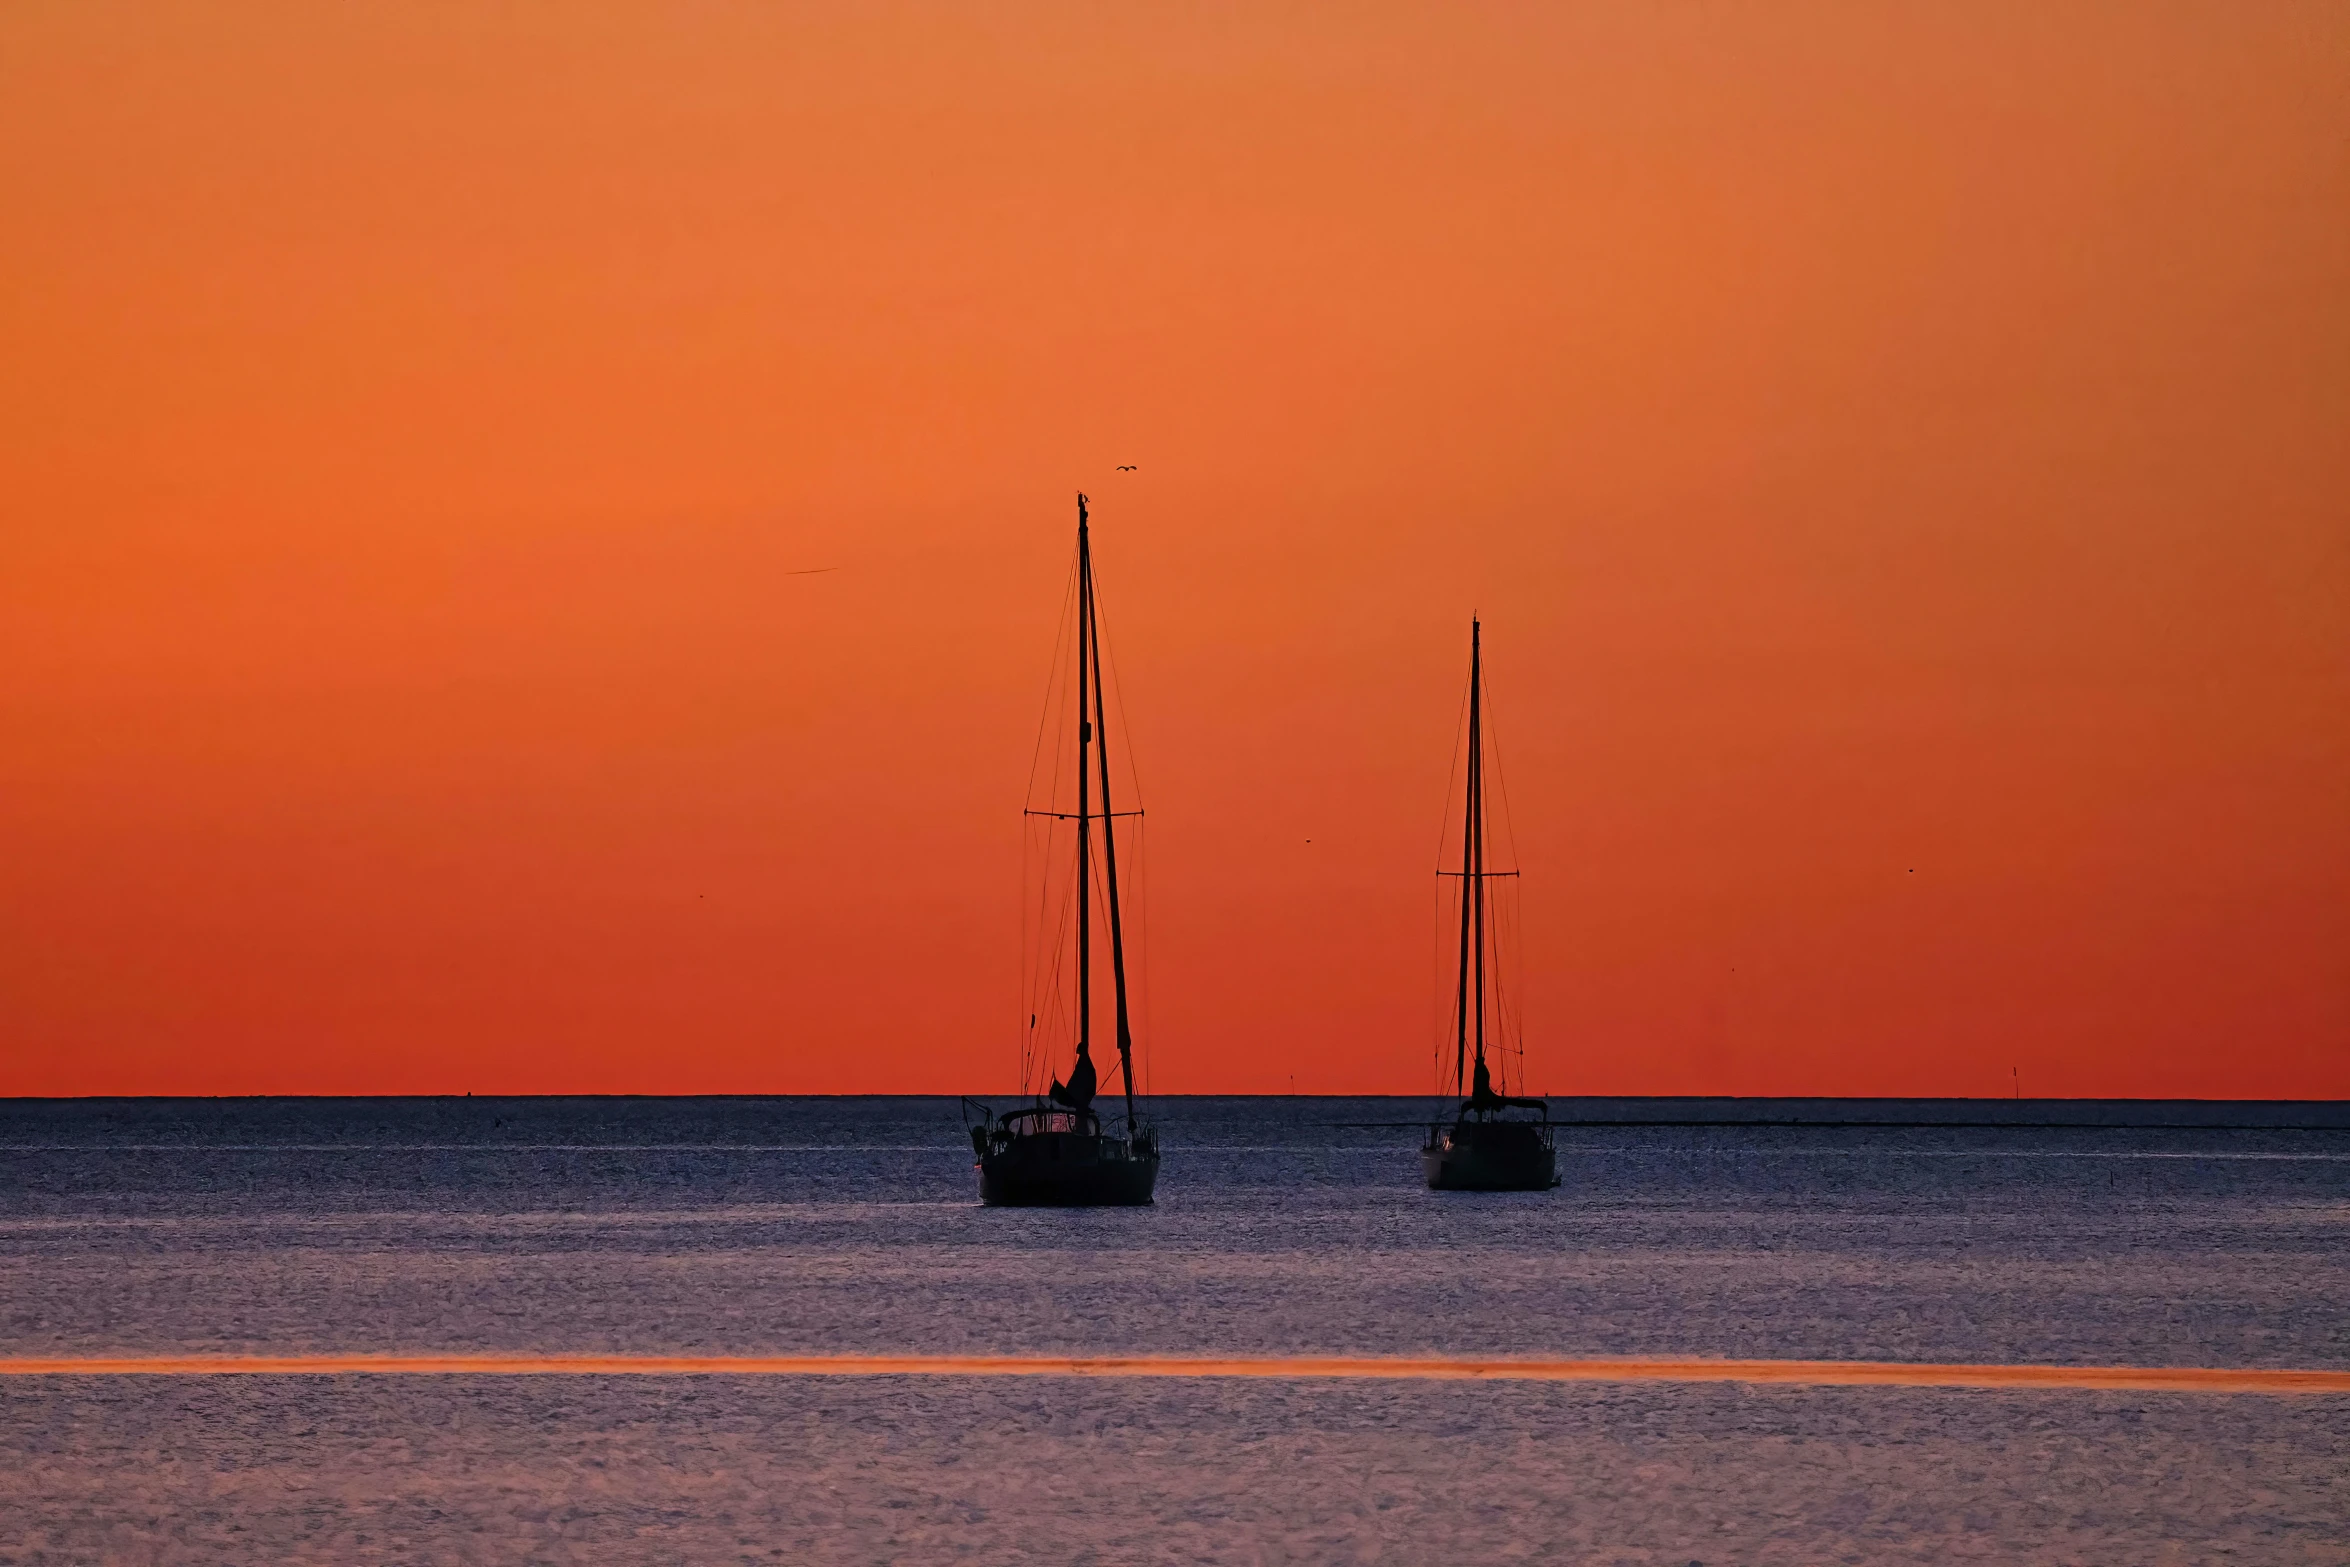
(0, 0, 2350, 1097)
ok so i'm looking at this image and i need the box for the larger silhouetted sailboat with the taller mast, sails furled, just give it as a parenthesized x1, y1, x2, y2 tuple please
(971, 496, 1159, 1208)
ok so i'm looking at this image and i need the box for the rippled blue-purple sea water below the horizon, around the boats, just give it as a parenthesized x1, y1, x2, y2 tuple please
(0, 1099, 2350, 1567)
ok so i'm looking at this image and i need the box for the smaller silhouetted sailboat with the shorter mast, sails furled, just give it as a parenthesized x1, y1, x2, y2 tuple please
(1419, 620, 1558, 1191)
